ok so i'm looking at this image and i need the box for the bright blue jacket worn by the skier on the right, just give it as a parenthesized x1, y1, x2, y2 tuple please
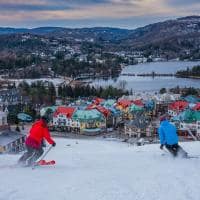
(158, 120, 178, 145)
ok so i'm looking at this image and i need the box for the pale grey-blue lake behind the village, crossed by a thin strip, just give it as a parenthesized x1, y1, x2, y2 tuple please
(88, 61, 200, 91)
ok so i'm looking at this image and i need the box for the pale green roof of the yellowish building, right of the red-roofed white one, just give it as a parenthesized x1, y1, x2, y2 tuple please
(72, 109, 104, 121)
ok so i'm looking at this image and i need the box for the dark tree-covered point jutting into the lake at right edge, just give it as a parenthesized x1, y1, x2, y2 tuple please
(176, 65, 200, 78)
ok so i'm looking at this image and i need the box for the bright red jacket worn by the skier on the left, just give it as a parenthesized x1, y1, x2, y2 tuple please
(26, 119, 54, 149)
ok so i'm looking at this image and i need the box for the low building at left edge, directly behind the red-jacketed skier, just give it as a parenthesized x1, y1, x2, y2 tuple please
(0, 130, 26, 153)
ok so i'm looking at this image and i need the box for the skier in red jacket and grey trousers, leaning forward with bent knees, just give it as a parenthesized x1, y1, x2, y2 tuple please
(18, 116, 56, 166)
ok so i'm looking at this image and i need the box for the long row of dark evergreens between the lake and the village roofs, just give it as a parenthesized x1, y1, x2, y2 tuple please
(58, 85, 129, 98)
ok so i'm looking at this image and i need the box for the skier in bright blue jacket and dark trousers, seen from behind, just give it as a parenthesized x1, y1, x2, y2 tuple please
(158, 115, 187, 157)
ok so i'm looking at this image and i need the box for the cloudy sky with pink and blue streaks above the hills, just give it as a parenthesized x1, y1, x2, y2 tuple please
(0, 0, 200, 29)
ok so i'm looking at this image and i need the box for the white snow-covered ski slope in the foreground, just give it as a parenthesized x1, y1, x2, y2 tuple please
(0, 139, 200, 200)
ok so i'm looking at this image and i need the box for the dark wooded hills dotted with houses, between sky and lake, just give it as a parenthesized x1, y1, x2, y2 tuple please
(0, 16, 200, 78)
